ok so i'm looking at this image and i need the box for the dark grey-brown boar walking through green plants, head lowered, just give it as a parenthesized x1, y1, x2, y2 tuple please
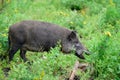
(8, 20, 87, 61)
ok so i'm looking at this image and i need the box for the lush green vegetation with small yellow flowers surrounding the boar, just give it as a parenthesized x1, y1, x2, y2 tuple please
(0, 0, 120, 80)
